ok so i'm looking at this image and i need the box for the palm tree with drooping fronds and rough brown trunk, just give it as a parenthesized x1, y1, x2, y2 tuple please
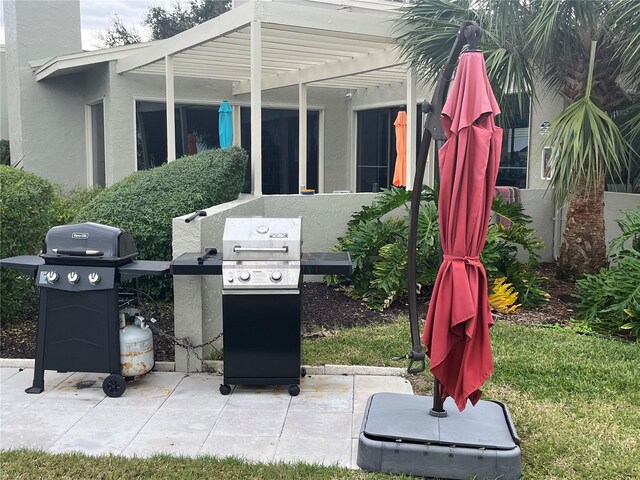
(402, 0, 640, 278)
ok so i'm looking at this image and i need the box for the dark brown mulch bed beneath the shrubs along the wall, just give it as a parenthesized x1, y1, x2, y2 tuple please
(0, 264, 576, 361)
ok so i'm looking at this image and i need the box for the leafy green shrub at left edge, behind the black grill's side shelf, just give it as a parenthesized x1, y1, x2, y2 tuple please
(0, 165, 54, 321)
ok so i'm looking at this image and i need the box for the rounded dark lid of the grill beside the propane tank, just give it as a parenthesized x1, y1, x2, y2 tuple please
(41, 222, 138, 265)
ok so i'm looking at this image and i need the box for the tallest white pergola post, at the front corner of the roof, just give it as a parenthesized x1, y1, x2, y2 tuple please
(251, 20, 262, 195)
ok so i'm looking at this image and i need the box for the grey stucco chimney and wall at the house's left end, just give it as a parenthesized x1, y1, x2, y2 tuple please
(3, 0, 86, 186)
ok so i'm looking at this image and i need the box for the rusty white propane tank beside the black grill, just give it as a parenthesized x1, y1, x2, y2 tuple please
(120, 317, 154, 377)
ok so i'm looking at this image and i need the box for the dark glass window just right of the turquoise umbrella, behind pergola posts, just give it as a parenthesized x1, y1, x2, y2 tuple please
(240, 107, 320, 194)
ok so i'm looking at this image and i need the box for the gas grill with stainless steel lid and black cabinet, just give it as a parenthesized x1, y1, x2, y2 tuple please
(171, 217, 351, 396)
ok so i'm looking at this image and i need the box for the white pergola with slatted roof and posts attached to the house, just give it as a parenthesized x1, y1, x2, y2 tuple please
(117, 0, 416, 195)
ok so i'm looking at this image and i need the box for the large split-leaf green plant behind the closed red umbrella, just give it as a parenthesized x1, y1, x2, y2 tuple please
(326, 186, 546, 310)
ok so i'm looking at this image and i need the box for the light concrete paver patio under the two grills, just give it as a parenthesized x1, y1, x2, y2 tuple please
(0, 368, 412, 468)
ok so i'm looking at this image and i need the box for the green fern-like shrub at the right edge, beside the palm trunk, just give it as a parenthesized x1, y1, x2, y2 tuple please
(576, 206, 640, 339)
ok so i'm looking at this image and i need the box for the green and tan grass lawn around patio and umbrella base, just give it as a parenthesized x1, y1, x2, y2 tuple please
(0, 320, 640, 479)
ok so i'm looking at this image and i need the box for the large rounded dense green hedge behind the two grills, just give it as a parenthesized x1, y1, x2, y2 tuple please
(75, 147, 247, 297)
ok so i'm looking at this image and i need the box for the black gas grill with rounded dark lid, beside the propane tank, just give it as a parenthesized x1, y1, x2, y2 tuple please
(0, 223, 169, 397)
